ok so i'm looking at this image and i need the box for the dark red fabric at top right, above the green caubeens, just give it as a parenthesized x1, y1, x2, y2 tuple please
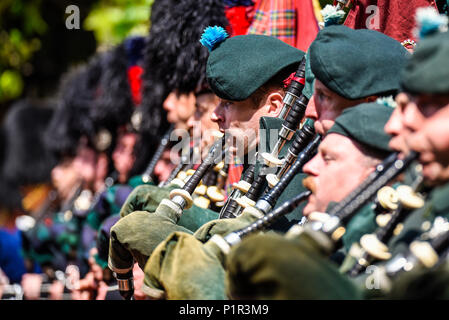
(344, 0, 437, 42)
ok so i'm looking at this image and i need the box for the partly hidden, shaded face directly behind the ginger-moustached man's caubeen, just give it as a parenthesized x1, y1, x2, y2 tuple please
(305, 79, 365, 135)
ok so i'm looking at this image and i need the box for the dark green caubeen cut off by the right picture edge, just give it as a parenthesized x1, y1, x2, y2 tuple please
(401, 32, 449, 94)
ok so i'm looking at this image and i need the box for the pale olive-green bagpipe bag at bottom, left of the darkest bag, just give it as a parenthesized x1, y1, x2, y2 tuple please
(142, 232, 226, 300)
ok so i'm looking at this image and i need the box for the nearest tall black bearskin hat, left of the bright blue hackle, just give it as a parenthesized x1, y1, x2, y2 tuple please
(144, 0, 227, 93)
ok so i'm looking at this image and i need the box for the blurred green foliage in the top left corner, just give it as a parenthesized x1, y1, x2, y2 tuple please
(0, 0, 333, 118)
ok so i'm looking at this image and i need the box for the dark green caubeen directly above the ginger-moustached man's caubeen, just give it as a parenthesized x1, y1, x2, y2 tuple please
(309, 25, 409, 100)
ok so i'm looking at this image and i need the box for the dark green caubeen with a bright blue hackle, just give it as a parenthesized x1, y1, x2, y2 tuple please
(200, 26, 304, 101)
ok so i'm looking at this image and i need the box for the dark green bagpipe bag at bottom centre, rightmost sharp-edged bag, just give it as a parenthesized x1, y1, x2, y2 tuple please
(226, 234, 362, 300)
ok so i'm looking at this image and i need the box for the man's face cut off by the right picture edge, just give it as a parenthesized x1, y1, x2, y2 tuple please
(405, 95, 449, 185)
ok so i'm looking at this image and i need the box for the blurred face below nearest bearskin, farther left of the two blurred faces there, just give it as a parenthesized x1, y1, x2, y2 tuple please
(162, 91, 195, 130)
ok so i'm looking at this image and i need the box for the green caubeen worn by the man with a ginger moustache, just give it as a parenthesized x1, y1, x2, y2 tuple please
(327, 102, 394, 153)
